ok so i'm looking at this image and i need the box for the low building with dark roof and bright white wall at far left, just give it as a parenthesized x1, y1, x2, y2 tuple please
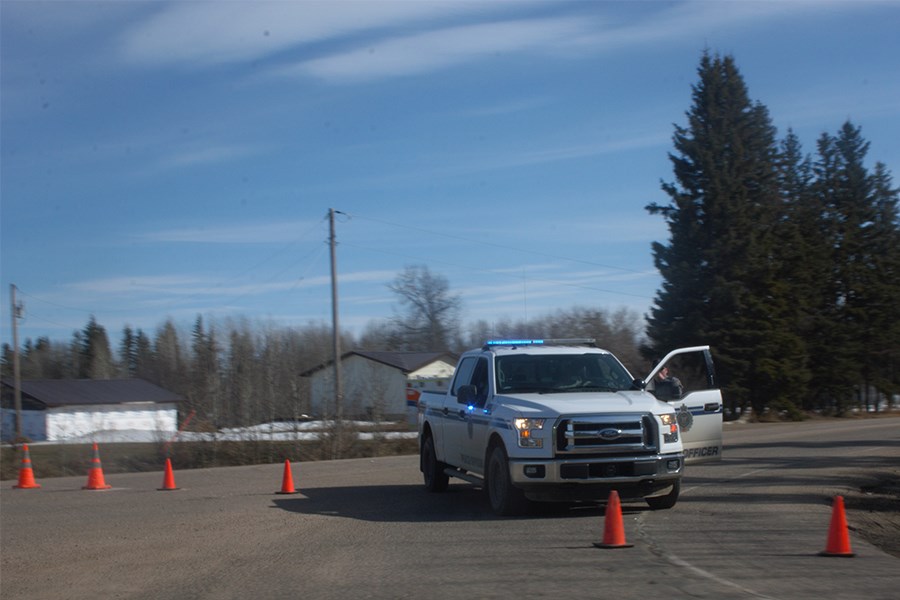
(0, 379, 183, 441)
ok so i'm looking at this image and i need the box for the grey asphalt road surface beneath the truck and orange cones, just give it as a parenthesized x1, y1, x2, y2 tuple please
(0, 418, 900, 600)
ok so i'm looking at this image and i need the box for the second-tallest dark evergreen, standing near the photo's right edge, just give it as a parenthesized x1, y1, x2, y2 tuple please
(812, 122, 897, 414)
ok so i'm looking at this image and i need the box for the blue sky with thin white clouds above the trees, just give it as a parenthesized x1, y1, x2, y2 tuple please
(0, 0, 900, 343)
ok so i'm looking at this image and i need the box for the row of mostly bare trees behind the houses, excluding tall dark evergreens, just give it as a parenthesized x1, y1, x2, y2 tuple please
(2, 302, 643, 431)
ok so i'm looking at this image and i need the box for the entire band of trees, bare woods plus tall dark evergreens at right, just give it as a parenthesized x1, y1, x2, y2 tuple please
(2, 53, 900, 428)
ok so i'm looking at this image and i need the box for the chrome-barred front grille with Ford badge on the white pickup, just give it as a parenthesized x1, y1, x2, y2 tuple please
(556, 414, 657, 454)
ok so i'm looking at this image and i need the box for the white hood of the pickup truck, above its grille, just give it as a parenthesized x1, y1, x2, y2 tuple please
(493, 390, 672, 418)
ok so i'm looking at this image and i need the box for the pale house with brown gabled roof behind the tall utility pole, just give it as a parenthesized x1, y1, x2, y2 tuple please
(301, 351, 456, 420)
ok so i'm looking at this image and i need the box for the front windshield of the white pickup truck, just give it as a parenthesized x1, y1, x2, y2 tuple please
(496, 352, 633, 393)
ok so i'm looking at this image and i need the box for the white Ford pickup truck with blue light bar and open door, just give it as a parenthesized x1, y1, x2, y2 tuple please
(418, 340, 722, 515)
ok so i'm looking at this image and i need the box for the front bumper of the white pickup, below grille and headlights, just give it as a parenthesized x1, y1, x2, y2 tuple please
(509, 452, 684, 501)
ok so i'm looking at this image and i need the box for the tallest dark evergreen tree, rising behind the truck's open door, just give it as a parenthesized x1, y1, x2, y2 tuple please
(647, 54, 799, 420)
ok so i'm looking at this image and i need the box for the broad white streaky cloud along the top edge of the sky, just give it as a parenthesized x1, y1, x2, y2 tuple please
(112, 0, 853, 83)
